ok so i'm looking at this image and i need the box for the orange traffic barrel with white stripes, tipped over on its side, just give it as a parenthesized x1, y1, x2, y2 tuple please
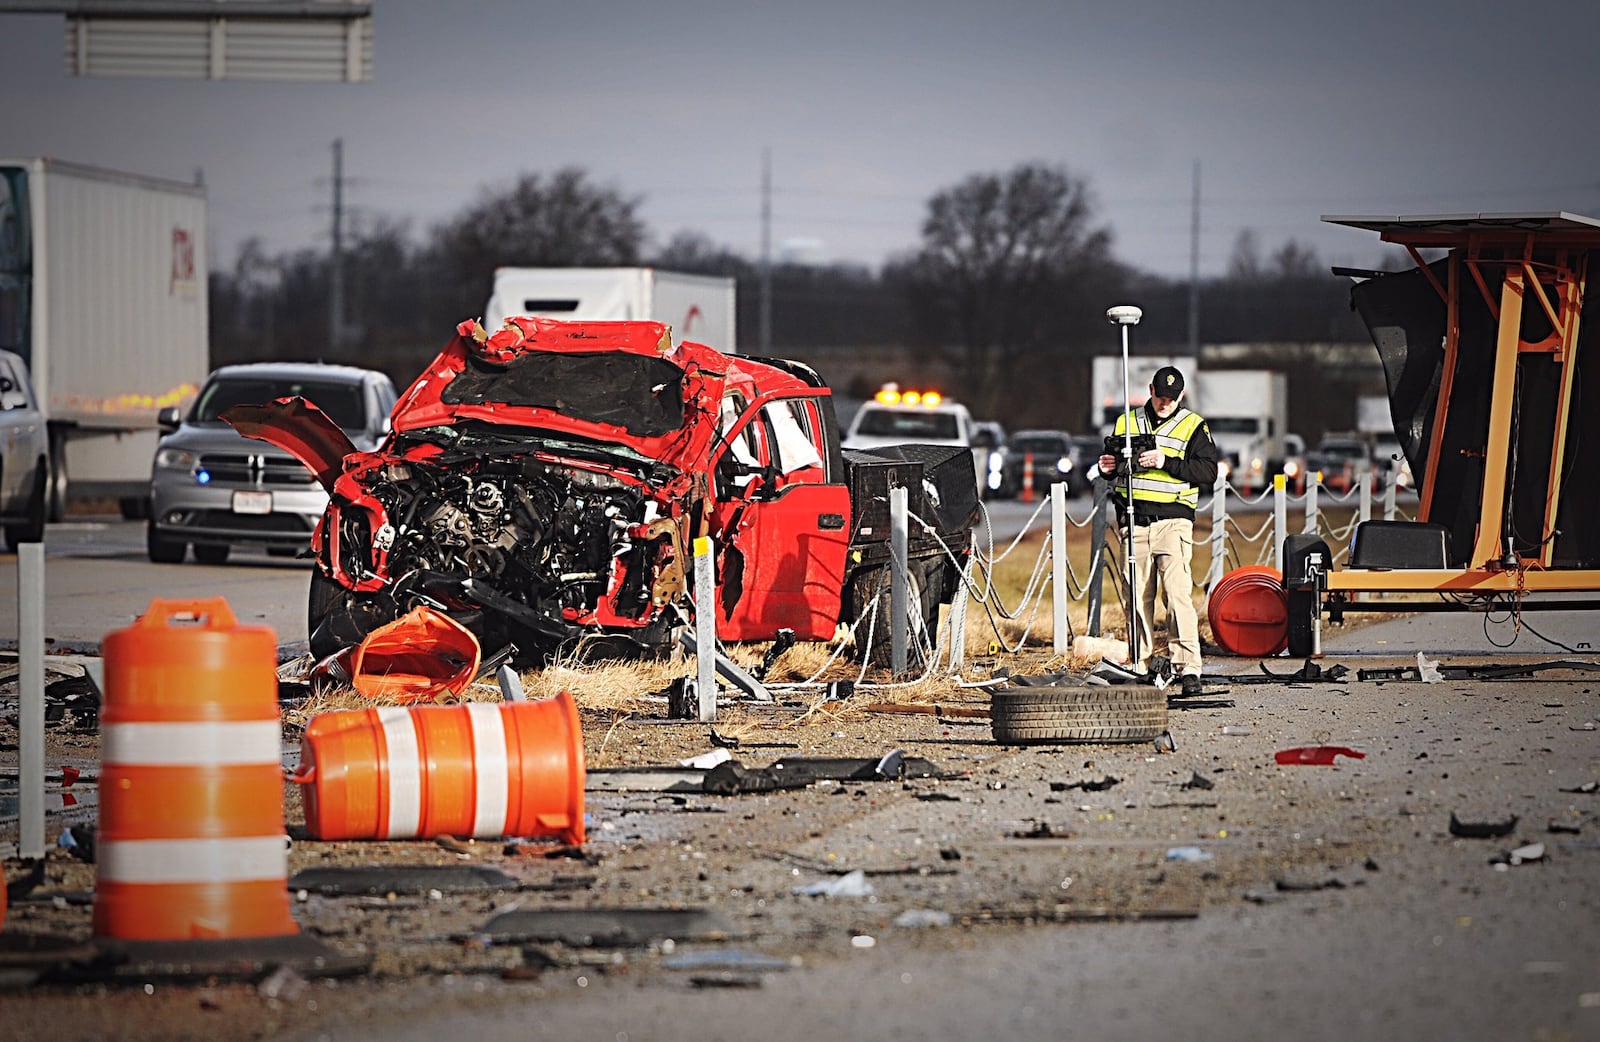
(291, 691, 584, 844)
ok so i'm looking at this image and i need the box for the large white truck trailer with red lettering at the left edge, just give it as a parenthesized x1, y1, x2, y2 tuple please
(0, 158, 210, 520)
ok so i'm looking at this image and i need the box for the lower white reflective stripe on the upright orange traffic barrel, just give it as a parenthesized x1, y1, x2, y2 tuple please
(94, 836, 290, 884)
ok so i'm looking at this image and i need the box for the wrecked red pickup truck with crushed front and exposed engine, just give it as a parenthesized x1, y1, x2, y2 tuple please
(226, 317, 978, 661)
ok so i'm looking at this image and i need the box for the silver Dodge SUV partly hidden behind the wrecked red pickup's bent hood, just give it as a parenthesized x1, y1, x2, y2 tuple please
(146, 362, 395, 565)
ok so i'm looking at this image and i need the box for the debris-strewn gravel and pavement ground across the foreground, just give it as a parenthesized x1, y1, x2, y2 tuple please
(0, 619, 1600, 1042)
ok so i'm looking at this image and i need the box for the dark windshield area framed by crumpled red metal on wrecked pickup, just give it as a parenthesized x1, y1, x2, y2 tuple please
(440, 351, 683, 437)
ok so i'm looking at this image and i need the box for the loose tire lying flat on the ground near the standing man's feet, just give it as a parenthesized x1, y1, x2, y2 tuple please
(989, 683, 1166, 744)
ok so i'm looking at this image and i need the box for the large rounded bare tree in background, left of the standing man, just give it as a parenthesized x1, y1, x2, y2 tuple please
(890, 163, 1118, 415)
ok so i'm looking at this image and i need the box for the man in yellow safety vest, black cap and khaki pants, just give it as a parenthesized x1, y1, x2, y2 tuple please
(1099, 365, 1218, 696)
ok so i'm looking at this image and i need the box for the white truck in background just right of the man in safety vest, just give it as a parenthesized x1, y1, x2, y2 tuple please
(1187, 370, 1290, 493)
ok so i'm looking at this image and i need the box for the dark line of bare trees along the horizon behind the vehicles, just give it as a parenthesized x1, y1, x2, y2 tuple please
(210, 163, 1388, 426)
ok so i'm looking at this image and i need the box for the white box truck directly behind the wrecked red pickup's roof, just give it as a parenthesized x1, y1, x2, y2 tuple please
(483, 267, 739, 354)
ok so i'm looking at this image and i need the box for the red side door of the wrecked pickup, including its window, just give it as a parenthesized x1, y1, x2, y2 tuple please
(712, 399, 850, 640)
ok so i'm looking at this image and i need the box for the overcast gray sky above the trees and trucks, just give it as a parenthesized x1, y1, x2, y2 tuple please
(0, 0, 1600, 277)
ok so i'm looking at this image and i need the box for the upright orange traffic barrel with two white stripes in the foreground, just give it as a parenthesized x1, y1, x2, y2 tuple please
(94, 597, 298, 941)
